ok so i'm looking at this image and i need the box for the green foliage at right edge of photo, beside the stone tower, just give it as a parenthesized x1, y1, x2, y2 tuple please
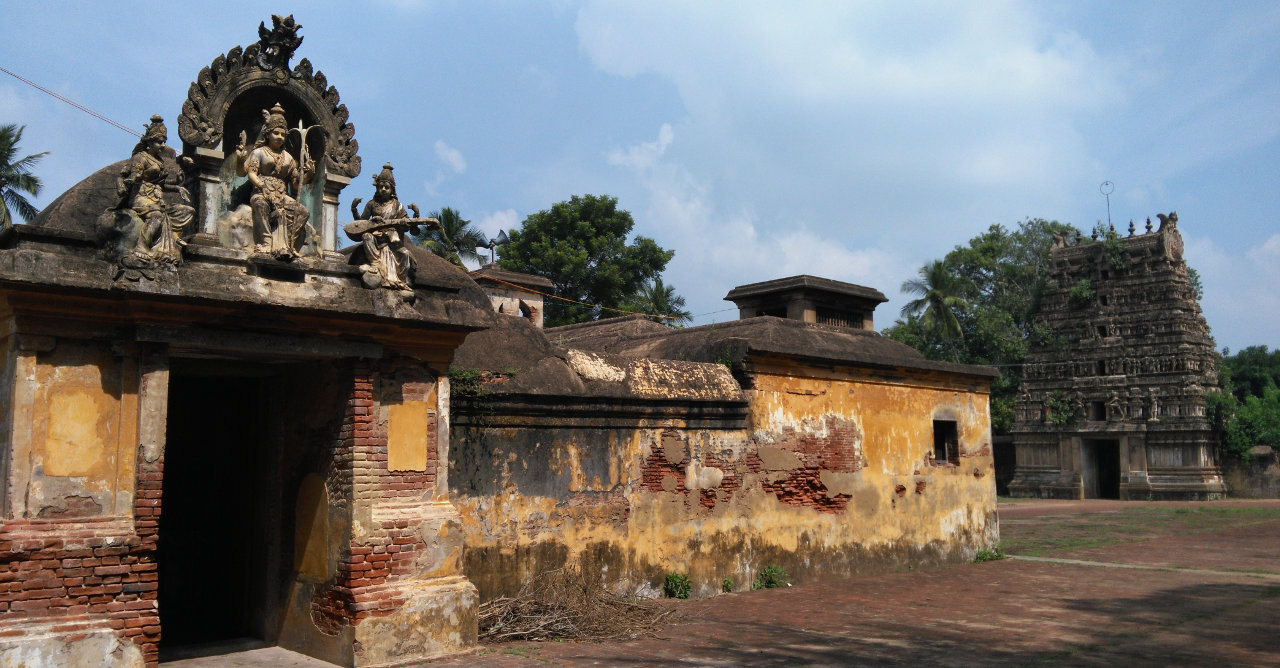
(1208, 346, 1280, 458)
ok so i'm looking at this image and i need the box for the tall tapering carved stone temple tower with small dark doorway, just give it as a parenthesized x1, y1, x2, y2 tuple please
(1009, 214, 1226, 499)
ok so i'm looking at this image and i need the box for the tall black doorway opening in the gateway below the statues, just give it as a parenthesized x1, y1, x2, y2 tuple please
(157, 369, 278, 659)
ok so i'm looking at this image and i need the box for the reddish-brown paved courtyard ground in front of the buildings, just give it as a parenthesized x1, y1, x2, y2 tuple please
(168, 500, 1280, 667)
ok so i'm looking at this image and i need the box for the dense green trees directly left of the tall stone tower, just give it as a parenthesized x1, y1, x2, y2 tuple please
(884, 219, 1078, 434)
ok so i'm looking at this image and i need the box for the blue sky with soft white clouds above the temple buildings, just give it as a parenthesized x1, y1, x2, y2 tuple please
(0, 0, 1280, 351)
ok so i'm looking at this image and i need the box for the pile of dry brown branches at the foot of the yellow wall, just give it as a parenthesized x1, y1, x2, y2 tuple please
(479, 568, 673, 642)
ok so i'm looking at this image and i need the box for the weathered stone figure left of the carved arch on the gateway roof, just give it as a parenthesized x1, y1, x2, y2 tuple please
(116, 115, 196, 265)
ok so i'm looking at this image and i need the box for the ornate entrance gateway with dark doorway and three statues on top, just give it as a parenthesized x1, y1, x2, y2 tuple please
(0, 17, 497, 665)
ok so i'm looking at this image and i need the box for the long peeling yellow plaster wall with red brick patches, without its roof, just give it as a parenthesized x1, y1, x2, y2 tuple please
(451, 358, 998, 599)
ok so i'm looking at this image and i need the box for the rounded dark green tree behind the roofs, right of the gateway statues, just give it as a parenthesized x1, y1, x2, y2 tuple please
(498, 195, 675, 326)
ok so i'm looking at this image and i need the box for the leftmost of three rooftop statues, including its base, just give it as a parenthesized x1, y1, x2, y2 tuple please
(115, 115, 195, 273)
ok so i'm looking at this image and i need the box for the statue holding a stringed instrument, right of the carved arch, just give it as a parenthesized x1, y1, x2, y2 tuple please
(343, 163, 440, 299)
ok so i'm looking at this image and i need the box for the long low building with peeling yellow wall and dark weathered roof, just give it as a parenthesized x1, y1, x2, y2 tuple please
(449, 299, 998, 600)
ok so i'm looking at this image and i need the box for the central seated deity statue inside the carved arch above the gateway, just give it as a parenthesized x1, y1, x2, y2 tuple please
(236, 104, 315, 261)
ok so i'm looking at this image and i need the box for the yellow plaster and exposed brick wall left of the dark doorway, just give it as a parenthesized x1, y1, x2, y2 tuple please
(0, 334, 160, 665)
